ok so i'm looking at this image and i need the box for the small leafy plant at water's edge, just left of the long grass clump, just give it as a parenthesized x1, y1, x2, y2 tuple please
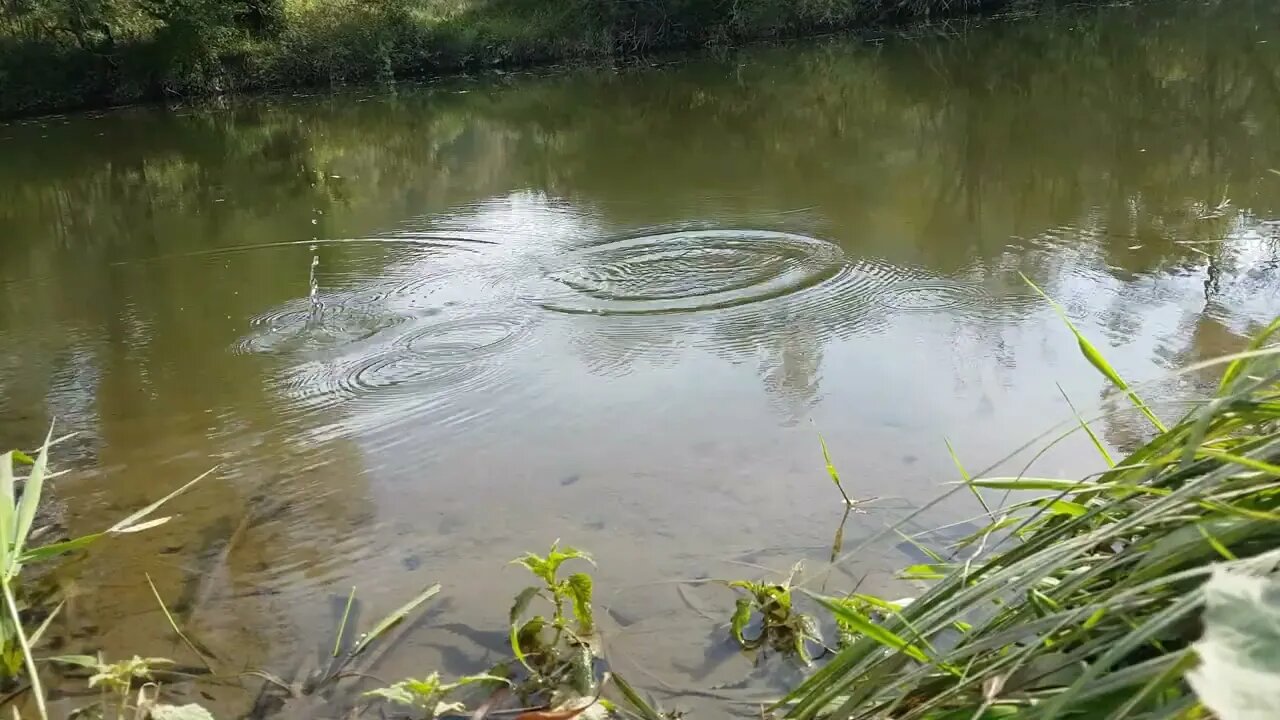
(726, 562, 820, 665)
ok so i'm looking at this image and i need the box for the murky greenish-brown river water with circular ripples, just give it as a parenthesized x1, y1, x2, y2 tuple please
(0, 1, 1280, 712)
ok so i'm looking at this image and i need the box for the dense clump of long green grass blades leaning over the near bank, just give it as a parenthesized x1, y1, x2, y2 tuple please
(780, 319, 1280, 720)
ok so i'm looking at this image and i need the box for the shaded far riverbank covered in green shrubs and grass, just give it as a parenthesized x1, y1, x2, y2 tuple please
(0, 0, 1024, 117)
